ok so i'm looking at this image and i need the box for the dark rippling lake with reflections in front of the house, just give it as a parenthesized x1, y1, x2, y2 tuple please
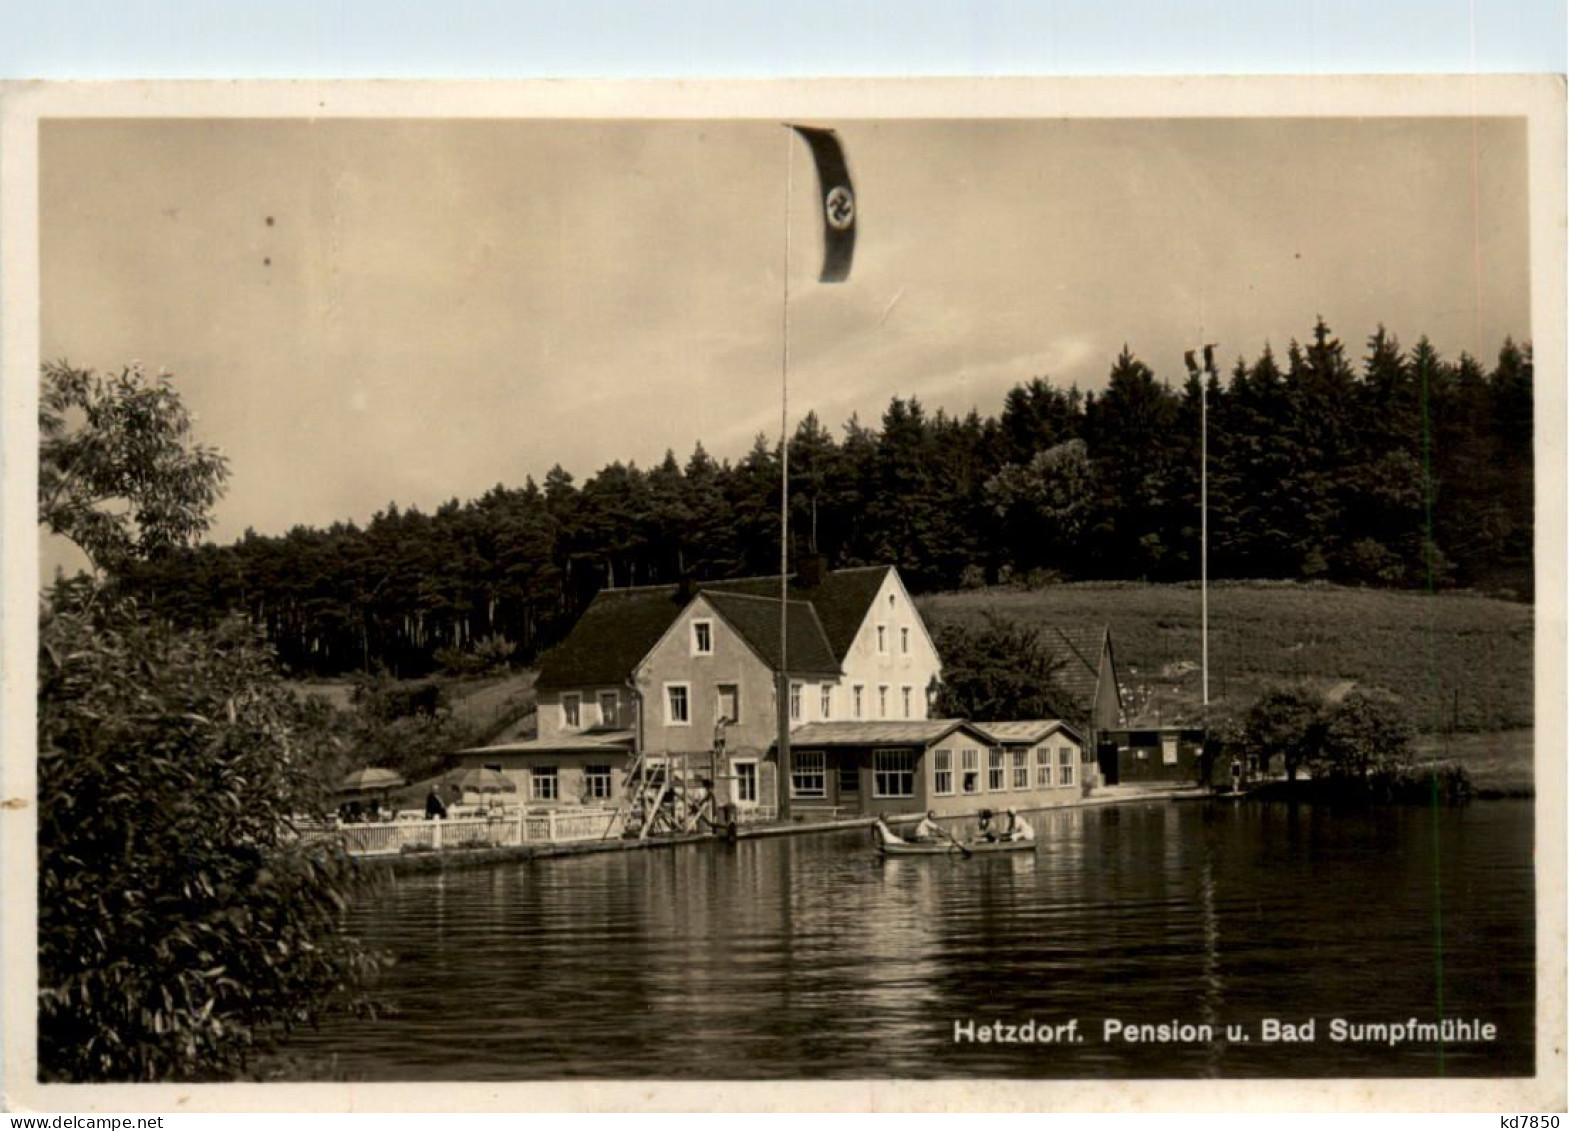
(287, 802, 1536, 1081)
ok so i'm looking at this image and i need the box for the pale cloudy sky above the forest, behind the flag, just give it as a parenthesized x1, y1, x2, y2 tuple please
(39, 118, 1531, 552)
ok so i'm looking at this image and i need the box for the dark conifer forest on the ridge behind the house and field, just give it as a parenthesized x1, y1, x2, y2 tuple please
(113, 320, 1533, 676)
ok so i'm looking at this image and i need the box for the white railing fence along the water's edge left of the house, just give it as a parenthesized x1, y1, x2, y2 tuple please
(303, 809, 621, 856)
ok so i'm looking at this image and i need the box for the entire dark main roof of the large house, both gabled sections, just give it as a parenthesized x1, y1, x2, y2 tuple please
(535, 565, 893, 689)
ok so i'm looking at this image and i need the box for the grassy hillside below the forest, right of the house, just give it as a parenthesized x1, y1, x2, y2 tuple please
(919, 582, 1534, 733)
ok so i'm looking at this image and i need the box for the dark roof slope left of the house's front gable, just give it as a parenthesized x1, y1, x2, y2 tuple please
(535, 588, 683, 687)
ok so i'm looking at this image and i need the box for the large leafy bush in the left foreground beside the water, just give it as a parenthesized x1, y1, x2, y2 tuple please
(38, 604, 377, 1082)
